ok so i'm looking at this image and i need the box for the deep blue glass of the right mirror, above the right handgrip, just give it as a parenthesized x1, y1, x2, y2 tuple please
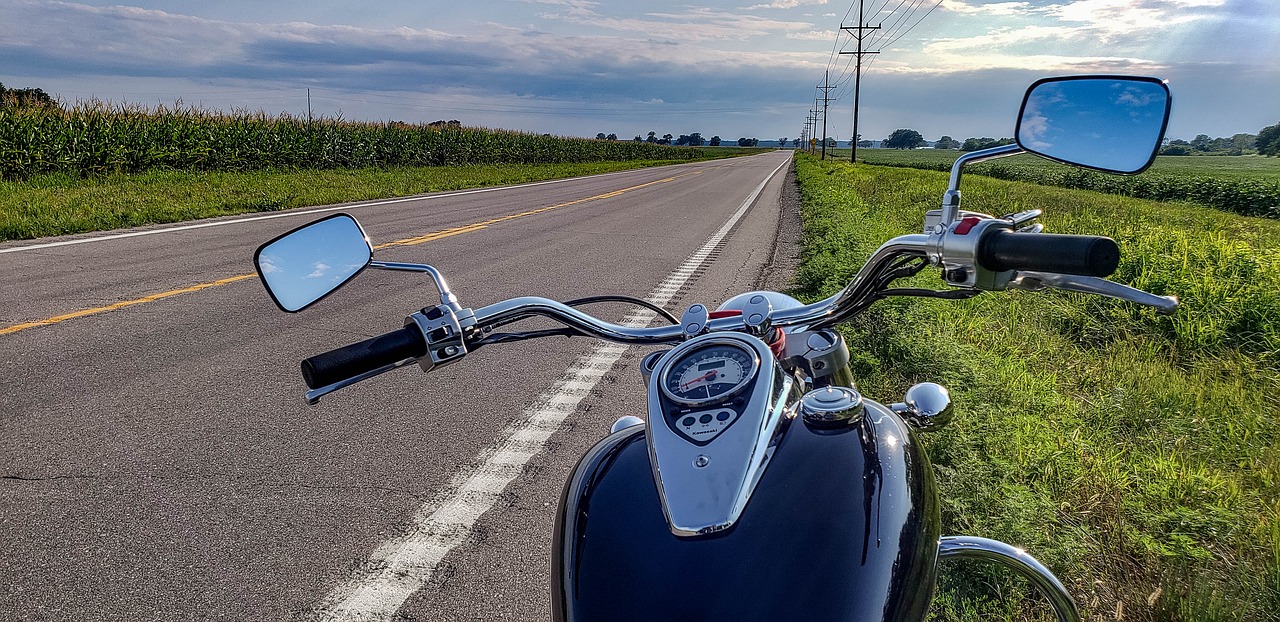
(1016, 76, 1170, 173)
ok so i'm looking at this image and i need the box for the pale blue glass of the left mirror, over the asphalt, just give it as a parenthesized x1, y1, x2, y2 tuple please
(253, 214, 374, 312)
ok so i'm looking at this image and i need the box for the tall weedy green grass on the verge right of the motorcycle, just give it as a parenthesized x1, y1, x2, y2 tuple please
(797, 157, 1280, 621)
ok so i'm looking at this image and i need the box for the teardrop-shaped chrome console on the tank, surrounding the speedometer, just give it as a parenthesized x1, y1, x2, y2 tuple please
(645, 333, 794, 536)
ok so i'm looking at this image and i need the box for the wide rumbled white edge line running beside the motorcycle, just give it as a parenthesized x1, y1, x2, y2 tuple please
(314, 151, 791, 622)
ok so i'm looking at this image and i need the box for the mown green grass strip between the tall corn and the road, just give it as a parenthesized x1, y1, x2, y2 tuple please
(0, 159, 721, 241)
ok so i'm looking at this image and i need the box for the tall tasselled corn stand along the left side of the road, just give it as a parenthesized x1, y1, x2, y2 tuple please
(0, 101, 708, 180)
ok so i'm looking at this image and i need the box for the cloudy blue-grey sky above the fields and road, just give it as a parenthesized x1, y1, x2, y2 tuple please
(0, 0, 1280, 141)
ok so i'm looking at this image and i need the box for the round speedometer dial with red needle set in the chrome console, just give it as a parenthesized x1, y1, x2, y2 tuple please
(662, 343, 756, 406)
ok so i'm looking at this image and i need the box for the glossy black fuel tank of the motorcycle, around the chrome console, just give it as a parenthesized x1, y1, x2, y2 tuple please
(552, 401, 940, 622)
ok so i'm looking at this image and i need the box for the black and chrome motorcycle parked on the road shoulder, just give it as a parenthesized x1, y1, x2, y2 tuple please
(255, 76, 1178, 622)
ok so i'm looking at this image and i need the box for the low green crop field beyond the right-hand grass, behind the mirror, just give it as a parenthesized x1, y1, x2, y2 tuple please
(828, 148, 1280, 218)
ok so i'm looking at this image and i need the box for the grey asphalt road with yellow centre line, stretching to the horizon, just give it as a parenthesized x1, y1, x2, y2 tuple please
(0, 152, 788, 621)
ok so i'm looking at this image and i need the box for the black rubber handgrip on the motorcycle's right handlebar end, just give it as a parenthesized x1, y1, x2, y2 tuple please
(978, 229, 1120, 276)
